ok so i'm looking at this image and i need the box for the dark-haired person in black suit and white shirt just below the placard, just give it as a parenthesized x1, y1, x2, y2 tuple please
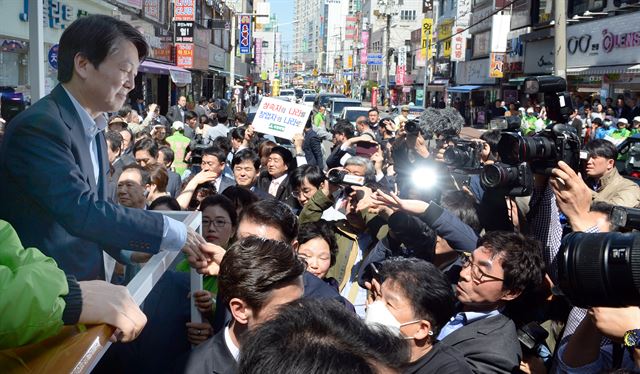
(258, 146, 297, 208)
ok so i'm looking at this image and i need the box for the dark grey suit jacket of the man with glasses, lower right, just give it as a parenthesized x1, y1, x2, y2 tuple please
(442, 314, 522, 373)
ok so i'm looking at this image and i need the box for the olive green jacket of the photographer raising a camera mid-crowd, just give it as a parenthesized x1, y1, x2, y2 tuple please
(300, 190, 389, 291)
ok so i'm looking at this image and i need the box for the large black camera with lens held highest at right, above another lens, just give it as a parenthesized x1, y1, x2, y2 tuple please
(498, 124, 580, 175)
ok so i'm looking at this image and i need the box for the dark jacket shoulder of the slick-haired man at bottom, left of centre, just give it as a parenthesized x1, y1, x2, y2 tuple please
(177, 329, 238, 374)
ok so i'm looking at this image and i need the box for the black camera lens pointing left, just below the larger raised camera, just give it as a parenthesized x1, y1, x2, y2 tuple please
(480, 162, 533, 196)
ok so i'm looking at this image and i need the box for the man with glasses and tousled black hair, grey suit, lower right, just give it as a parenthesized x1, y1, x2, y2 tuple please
(438, 231, 544, 373)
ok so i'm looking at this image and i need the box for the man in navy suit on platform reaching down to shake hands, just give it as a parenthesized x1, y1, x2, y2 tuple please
(0, 15, 206, 280)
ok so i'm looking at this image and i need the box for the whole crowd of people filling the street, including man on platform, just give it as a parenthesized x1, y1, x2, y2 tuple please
(0, 16, 640, 373)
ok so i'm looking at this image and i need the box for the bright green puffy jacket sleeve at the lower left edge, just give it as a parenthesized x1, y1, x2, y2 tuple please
(0, 220, 79, 349)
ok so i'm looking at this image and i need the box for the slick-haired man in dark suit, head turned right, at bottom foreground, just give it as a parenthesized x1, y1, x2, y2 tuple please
(177, 236, 306, 374)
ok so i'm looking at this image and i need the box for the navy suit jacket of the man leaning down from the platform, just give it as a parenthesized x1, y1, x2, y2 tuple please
(0, 85, 163, 280)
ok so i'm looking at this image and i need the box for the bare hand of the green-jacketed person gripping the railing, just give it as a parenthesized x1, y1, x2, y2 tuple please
(78, 280, 147, 342)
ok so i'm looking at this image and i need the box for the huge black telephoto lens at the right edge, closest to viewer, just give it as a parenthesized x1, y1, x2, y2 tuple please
(558, 232, 640, 308)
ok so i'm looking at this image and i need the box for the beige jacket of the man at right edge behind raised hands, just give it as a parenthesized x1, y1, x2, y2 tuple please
(592, 168, 640, 208)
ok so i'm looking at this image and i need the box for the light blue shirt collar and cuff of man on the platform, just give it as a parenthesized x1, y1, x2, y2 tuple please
(62, 86, 187, 251)
